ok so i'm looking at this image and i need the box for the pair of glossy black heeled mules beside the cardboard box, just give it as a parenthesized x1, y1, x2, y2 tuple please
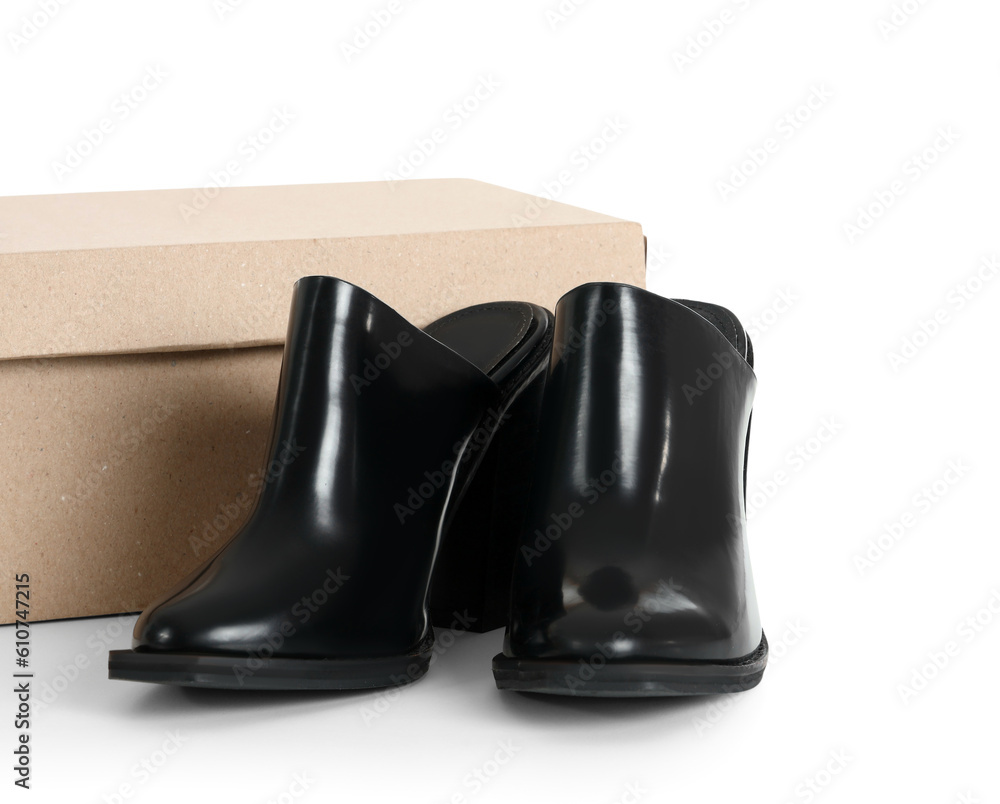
(109, 276, 767, 696)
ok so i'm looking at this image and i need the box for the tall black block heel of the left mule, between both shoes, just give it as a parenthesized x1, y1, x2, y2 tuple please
(429, 361, 547, 633)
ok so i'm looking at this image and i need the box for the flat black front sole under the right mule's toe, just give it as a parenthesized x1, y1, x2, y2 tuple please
(493, 634, 767, 698)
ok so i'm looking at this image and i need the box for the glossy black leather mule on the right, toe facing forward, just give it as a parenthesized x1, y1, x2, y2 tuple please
(493, 283, 767, 697)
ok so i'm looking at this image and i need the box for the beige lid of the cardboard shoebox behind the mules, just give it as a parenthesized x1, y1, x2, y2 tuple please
(0, 179, 642, 360)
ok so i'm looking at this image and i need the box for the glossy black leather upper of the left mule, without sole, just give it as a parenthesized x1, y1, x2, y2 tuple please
(134, 276, 501, 658)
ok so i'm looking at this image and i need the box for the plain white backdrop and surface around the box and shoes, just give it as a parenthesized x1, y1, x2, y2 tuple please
(0, 0, 1000, 804)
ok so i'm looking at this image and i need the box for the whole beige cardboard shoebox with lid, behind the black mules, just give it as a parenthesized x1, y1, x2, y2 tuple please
(0, 180, 645, 622)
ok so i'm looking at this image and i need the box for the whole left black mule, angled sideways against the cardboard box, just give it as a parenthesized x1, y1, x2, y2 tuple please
(109, 276, 552, 689)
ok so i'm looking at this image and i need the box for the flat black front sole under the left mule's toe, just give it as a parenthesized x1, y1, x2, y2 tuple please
(108, 636, 434, 690)
